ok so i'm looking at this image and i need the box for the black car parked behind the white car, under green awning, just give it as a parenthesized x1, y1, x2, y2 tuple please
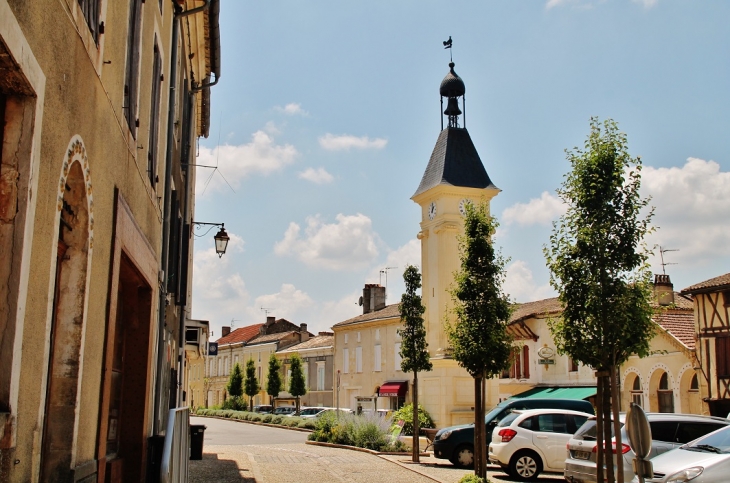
(433, 398, 594, 468)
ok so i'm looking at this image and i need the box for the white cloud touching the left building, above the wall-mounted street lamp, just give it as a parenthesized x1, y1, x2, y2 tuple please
(195, 131, 299, 196)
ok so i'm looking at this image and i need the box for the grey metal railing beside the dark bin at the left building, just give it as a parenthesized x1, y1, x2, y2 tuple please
(160, 407, 190, 483)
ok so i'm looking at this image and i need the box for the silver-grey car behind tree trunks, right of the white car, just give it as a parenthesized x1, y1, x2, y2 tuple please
(564, 413, 730, 483)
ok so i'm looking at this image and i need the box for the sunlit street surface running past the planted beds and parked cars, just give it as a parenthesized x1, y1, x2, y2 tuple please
(189, 417, 564, 483)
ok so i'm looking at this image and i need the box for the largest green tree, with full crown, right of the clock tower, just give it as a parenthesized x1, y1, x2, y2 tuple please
(544, 118, 654, 483)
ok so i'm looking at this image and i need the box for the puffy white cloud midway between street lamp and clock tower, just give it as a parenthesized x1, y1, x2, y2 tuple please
(274, 213, 378, 270)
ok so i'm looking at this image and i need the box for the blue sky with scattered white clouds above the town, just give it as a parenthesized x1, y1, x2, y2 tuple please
(192, 0, 730, 339)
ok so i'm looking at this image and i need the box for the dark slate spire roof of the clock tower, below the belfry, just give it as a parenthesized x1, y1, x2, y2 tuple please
(413, 127, 498, 196)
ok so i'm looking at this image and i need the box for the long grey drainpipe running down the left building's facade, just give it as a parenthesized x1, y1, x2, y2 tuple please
(154, 0, 212, 433)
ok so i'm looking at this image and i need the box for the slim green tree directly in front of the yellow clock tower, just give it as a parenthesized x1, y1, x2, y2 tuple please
(446, 202, 511, 478)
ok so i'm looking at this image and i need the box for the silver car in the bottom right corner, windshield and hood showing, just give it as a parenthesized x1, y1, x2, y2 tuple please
(632, 426, 730, 483)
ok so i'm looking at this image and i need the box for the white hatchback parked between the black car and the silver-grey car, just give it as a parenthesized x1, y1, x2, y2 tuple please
(489, 409, 593, 481)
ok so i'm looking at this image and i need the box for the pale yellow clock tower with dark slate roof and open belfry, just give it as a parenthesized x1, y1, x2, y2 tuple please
(411, 62, 500, 426)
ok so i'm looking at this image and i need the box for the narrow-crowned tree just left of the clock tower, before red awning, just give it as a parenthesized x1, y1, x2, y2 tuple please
(398, 265, 433, 463)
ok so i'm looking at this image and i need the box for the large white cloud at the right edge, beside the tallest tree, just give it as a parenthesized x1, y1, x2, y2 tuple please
(642, 158, 730, 265)
